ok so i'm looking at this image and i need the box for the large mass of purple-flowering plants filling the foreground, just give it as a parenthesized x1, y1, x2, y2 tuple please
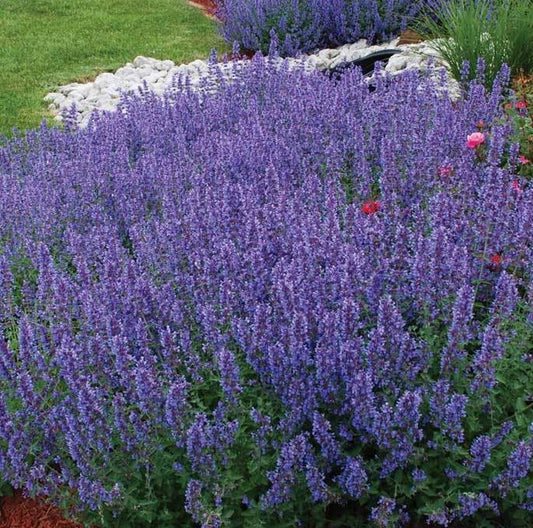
(0, 57, 533, 528)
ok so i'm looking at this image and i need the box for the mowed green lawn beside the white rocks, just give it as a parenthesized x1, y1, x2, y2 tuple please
(0, 0, 228, 134)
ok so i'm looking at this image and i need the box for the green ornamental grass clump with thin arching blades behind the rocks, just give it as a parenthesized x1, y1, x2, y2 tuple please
(418, 0, 533, 86)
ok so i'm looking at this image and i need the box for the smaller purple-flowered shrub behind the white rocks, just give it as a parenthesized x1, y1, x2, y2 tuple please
(218, 0, 424, 56)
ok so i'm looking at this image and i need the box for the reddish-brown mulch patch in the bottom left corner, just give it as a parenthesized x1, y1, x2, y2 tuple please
(0, 491, 82, 528)
